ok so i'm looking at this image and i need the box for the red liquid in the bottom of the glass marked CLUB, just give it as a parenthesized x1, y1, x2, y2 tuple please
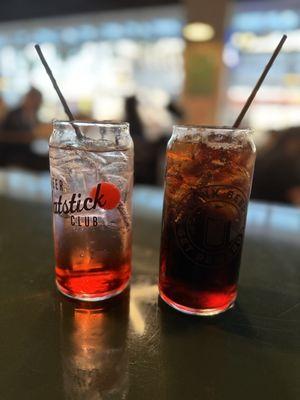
(55, 216, 131, 299)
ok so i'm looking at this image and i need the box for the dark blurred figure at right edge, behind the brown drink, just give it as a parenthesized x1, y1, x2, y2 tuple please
(252, 127, 300, 205)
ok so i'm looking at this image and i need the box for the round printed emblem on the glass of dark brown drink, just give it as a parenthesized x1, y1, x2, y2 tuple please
(174, 185, 247, 268)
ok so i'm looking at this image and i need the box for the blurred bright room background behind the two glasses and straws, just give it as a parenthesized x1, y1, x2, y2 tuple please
(0, 0, 300, 206)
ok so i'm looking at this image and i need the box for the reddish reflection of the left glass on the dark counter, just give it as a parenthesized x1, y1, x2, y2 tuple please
(60, 290, 129, 400)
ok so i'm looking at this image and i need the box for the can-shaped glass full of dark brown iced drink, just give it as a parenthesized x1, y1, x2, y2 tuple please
(159, 126, 255, 315)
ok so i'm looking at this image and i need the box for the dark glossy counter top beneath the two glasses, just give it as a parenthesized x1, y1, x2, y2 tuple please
(0, 171, 300, 400)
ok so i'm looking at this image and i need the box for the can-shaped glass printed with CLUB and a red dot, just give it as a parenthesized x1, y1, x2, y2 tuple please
(49, 121, 133, 301)
